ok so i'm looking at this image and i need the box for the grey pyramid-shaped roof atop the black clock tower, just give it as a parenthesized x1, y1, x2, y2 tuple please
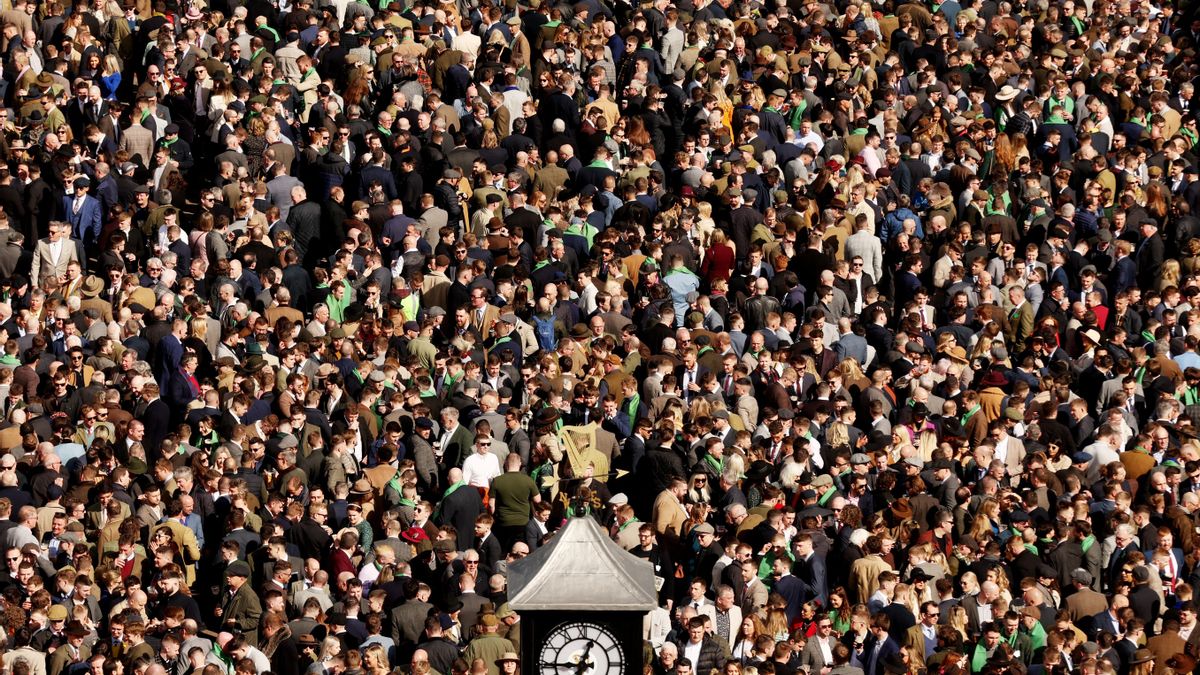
(509, 516, 658, 611)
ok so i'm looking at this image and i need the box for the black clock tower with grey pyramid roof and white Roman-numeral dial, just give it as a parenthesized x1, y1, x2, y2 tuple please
(509, 516, 658, 675)
